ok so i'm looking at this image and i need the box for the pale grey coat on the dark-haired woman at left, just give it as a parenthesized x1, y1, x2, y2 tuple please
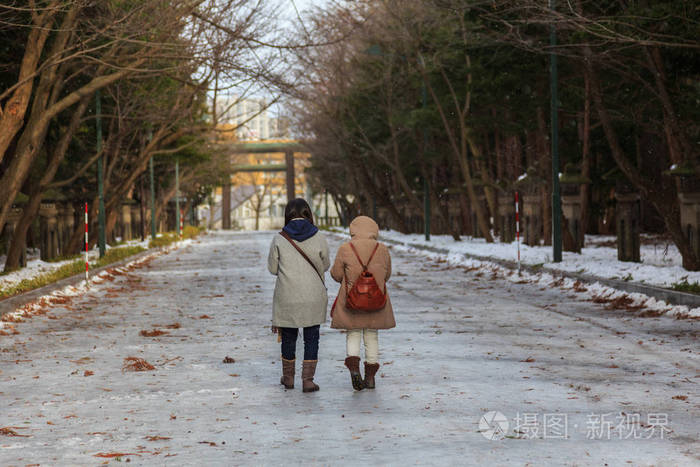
(267, 232, 331, 328)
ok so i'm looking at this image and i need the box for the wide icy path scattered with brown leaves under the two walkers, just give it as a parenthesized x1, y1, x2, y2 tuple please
(0, 233, 700, 466)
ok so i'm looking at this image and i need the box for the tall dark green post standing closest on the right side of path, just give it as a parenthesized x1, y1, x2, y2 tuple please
(549, 0, 562, 263)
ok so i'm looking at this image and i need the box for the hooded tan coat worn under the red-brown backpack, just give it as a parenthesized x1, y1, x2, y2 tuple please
(331, 216, 396, 329)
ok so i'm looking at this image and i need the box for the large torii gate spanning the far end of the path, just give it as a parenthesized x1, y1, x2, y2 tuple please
(221, 141, 304, 229)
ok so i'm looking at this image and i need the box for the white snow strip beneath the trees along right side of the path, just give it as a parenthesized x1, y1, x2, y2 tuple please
(381, 230, 700, 288)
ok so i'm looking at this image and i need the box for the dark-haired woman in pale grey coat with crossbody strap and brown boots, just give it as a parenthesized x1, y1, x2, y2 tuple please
(267, 198, 330, 392)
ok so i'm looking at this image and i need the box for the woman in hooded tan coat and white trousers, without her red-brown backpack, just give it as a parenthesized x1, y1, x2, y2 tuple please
(331, 216, 396, 391)
